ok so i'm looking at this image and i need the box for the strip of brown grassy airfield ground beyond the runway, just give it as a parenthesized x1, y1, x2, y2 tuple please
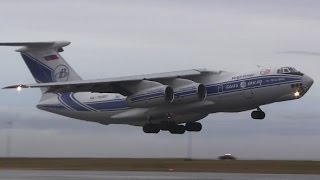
(0, 158, 320, 174)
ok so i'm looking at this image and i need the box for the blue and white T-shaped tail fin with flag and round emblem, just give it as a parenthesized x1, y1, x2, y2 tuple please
(0, 41, 81, 83)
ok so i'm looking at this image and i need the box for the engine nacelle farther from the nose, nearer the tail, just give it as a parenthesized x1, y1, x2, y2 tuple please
(127, 85, 174, 107)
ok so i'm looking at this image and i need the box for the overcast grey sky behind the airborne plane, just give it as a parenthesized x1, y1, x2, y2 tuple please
(0, 0, 320, 160)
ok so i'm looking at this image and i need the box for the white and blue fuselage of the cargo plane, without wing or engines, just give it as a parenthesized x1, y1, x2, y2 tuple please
(37, 69, 309, 126)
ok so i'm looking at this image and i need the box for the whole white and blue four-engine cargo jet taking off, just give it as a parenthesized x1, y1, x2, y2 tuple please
(0, 41, 313, 134)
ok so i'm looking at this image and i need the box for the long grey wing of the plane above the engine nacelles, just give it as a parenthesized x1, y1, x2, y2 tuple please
(3, 69, 215, 96)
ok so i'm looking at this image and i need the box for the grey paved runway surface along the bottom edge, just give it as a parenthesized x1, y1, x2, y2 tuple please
(0, 170, 320, 180)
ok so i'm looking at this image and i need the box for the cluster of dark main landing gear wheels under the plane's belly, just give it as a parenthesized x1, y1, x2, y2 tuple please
(143, 121, 202, 134)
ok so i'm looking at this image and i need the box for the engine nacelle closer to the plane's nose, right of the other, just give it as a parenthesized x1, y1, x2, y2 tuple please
(174, 83, 207, 103)
